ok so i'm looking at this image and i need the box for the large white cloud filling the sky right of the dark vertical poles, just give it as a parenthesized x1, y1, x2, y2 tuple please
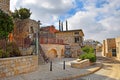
(65, 0, 120, 41)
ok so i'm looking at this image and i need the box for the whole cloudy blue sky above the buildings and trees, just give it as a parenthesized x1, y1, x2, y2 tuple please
(10, 0, 120, 41)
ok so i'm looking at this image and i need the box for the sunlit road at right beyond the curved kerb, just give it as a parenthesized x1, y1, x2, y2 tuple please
(75, 52, 120, 80)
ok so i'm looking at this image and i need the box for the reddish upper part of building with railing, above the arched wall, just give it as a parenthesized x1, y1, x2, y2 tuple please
(39, 25, 63, 44)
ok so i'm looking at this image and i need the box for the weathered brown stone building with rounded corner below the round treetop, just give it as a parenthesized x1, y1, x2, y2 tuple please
(14, 19, 39, 47)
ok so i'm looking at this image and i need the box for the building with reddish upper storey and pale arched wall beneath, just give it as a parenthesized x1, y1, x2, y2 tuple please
(39, 25, 65, 59)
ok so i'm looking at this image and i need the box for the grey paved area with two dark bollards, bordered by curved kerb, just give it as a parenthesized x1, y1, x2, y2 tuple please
(0, 58, 101, 80)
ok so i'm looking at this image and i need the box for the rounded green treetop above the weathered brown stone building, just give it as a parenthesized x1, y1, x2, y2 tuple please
(12, 8, 32, 19)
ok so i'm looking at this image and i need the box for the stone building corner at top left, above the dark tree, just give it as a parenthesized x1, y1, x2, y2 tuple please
(0, 0, 10, 14)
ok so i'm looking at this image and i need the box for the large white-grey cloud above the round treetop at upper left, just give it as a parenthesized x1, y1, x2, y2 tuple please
(11, 0, 74, 24)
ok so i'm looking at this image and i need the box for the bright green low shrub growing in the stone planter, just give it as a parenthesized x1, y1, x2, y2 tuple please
(79, 53, 96, 62)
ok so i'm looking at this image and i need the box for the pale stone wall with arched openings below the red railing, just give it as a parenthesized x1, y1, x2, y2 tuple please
(41, 44, 65, 59)
